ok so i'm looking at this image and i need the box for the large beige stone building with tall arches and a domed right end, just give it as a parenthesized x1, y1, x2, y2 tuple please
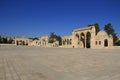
(62, 26, 113, 48)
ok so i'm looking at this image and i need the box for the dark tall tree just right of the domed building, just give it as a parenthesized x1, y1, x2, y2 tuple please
(104, 23, 118, 45)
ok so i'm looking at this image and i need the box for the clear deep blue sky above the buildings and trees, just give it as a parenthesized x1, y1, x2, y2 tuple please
(0, 0, 120, 37)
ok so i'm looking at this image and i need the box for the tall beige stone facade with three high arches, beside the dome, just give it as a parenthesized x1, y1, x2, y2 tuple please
(72, 26, 95, 48)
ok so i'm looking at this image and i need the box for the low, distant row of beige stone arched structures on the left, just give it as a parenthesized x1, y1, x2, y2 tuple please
(14, 36, 59, 47)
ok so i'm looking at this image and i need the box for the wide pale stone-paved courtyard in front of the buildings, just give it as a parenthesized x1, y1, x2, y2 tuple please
(0, 46, 120, 80)
